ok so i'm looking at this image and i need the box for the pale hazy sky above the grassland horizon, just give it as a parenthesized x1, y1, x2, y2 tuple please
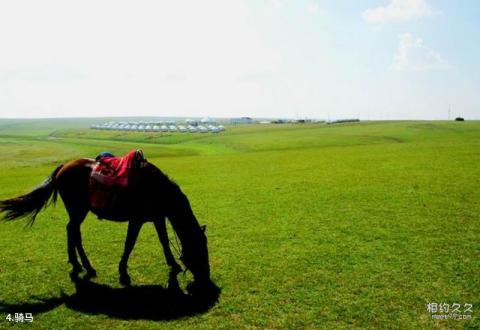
(0, 0, 480, 119)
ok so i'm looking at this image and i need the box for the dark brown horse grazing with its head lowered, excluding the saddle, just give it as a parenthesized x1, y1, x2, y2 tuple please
(0, 159, 213, 287)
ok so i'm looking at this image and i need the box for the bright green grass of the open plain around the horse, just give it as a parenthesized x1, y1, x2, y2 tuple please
(0, 120, 480, 329)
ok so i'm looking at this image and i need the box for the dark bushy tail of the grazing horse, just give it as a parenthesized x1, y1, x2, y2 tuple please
(0, 164, 63, 227)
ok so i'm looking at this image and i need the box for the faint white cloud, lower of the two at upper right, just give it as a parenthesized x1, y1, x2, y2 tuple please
(392, 33, 448, 71)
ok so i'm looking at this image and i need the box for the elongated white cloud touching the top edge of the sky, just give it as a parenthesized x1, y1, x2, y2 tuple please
(362, 0, 438, 24)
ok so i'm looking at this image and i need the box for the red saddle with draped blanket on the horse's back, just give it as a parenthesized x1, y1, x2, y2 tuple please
(89, 150, 148, 217)
